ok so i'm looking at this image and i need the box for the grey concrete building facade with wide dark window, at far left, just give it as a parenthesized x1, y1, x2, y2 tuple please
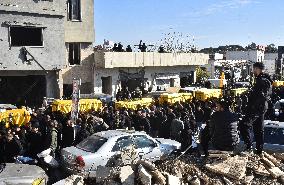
(0, 0, 66, 105)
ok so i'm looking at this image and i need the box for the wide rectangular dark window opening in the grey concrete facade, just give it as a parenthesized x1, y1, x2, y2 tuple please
(10, 27, 43, 46)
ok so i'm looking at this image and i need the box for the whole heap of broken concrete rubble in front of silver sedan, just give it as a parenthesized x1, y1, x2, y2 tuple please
(93, 147, 284, 185)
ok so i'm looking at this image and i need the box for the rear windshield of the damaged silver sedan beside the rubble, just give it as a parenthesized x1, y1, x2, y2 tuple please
(76, 136, 107, 153)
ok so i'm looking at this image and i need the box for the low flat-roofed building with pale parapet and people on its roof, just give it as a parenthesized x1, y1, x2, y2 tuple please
(93, 52, 209, 96)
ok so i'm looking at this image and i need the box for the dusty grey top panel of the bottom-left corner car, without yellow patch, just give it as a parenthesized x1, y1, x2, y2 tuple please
(0, 163, 47, 184)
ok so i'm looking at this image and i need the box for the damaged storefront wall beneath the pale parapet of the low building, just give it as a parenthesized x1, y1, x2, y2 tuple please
(94, 66, 196, 96)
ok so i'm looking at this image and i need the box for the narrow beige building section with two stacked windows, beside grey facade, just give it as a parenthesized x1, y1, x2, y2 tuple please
(61, 0, 95, 97)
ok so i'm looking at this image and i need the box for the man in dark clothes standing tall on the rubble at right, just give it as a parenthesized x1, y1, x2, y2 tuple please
(239, 62, 273, 154)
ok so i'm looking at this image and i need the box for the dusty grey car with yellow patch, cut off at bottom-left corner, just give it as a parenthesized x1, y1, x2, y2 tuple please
(0, 163, 48, 185)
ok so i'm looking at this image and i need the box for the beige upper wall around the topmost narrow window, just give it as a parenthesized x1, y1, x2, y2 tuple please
(65, 0, 95, 42)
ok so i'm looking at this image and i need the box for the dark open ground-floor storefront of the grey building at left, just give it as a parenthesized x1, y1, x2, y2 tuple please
(0, 71, 60, 106)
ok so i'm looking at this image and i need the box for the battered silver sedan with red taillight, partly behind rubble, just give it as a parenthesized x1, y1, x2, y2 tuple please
(61, 130, 181, 178)
